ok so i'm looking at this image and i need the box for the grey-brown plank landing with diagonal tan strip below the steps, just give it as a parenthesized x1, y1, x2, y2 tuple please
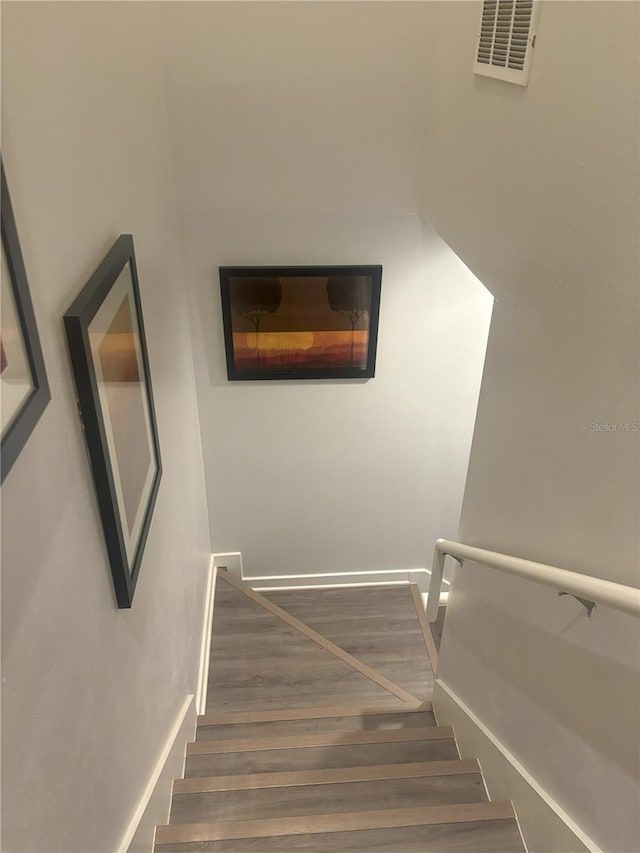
(207, 579, 433, 712)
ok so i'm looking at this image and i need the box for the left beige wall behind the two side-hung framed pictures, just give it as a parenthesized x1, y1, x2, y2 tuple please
(2, 3, 210, 853)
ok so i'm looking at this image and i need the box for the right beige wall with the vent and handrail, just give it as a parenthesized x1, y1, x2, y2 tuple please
(424, 2, 640, 853)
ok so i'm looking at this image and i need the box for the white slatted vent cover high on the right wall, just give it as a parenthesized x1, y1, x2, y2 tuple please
(473, 0, 540, 86)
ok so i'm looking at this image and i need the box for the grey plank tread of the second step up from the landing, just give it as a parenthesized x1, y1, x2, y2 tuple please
(185, 738, 459, 777)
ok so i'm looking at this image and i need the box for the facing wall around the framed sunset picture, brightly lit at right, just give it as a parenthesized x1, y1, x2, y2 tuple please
(166, 3, 491, 576)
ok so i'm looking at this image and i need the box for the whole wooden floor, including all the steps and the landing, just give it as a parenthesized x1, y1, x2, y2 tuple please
(155, 574, 523, 853)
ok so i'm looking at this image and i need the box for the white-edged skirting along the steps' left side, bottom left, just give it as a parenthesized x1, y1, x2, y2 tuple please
(118, 693, 197, 853)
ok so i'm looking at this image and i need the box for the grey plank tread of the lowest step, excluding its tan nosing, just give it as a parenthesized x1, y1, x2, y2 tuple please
(196, 711, 436, 740)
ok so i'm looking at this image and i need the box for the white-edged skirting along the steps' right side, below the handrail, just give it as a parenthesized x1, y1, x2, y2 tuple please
(432, 678, 602, 853)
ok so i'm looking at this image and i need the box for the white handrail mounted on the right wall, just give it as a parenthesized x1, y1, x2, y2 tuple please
(427, 539, 640, 622)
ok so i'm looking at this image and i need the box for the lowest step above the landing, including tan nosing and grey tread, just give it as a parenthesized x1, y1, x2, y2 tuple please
(196, 702, 436, 740)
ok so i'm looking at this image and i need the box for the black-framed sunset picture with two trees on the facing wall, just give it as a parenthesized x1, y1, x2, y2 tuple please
(220, 266, 382, 379)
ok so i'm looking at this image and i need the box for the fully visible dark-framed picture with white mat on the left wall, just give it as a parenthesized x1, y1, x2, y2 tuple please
(64, 234, 162, 607)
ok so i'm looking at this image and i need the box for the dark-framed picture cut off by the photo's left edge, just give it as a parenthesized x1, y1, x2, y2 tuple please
(0, 156, 51, 482)
